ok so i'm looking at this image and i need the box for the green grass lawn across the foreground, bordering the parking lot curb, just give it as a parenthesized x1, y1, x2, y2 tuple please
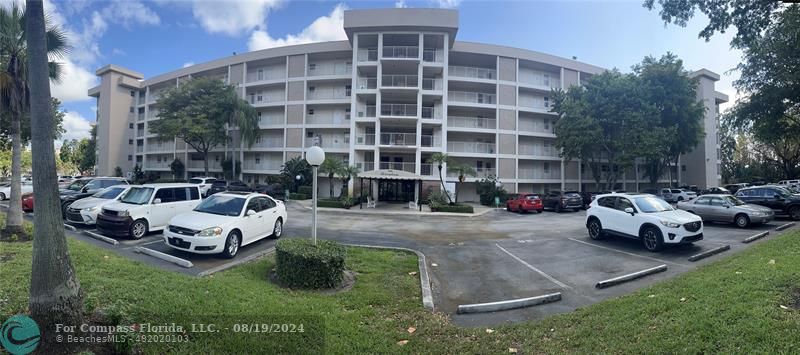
(0, 211, 800, 353)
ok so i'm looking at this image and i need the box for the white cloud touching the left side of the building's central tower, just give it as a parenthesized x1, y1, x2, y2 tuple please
(247, 4, 347, 51)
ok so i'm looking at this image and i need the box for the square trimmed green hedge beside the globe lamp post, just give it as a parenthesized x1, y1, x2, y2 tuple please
(275, 238, 346, 289)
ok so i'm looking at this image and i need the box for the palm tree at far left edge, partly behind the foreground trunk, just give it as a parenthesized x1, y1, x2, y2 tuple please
(0, 3, 67, 236)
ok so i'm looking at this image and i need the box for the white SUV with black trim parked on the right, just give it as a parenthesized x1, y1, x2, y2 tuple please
(586, 193, 703, 252)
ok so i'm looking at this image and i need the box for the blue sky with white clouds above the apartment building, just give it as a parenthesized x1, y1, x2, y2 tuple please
(20, 0, 741, 145)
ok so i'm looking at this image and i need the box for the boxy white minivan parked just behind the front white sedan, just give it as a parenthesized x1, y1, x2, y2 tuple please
(97, 183, 200, 239)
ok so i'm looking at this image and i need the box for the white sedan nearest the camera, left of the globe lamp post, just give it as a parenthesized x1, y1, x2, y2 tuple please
(164, 192, 286, 258)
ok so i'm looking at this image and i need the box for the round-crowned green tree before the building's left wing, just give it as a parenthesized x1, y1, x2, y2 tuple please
(150, 77, 259, 175)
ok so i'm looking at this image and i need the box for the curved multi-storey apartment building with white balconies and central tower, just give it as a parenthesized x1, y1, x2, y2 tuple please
(89, 9, 727, 201)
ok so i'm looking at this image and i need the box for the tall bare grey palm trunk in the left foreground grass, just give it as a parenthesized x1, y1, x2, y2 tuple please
(25, 0, 83, 354)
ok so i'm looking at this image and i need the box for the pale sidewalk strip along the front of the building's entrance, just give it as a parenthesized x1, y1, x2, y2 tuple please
(286, 200, 494, 217)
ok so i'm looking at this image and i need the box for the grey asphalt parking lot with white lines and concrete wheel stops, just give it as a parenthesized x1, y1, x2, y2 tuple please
(3, 203, 797, 326)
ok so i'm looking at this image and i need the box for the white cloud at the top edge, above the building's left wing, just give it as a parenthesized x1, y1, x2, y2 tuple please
(192, 0, 281, 36)
